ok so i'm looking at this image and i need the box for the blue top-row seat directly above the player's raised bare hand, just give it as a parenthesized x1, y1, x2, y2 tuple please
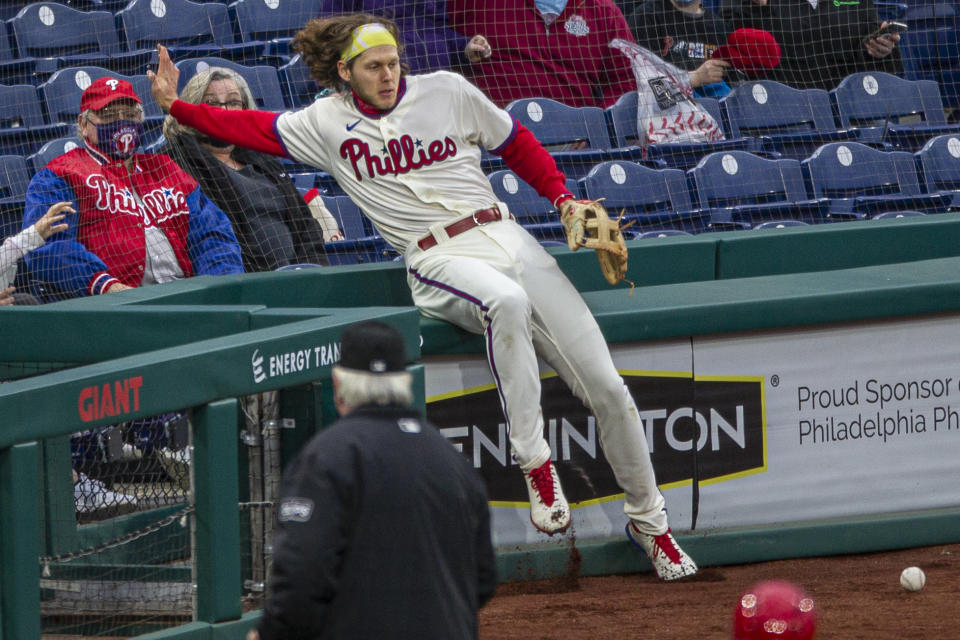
(116, 0, 263, 62)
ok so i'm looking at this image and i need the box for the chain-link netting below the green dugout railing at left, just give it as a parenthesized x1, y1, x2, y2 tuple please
(28, 392, 282, 637)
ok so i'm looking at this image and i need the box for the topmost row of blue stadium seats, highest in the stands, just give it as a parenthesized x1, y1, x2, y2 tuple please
(0, 0, 960, 107)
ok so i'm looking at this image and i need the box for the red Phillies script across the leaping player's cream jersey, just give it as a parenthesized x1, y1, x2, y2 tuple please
(340, 134, 457, 182)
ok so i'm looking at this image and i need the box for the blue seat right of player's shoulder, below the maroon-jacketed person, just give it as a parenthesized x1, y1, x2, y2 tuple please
(507, 98, 611, 178)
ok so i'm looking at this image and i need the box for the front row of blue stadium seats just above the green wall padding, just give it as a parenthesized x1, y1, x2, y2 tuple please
(286, 136, 960, 264)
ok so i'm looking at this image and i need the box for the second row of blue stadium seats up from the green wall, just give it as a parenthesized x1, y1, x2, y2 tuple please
(0, 63, 960, 164)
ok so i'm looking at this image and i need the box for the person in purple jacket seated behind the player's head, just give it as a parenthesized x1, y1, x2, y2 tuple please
(318, 0, 491, 73)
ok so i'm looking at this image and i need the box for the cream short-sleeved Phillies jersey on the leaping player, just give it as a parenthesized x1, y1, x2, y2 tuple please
(276, 71, 514, 253)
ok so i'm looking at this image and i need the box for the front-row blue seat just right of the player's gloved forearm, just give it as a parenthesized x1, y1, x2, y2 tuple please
(580, 160, 706, 232)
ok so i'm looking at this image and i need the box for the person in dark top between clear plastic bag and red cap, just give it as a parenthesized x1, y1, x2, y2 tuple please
(626, 0, 733, 97)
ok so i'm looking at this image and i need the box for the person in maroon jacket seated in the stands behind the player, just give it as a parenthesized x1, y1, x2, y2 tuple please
(448, 0, 637, 107)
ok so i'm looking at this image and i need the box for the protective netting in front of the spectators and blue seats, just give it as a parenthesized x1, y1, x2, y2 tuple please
(0, 0, 960, 303)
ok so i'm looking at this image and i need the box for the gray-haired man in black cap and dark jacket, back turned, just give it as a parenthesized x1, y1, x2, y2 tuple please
(248, 321, 496, 640)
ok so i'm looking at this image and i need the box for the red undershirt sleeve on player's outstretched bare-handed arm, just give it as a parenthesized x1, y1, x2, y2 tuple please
(170, 100, 289, 156)
